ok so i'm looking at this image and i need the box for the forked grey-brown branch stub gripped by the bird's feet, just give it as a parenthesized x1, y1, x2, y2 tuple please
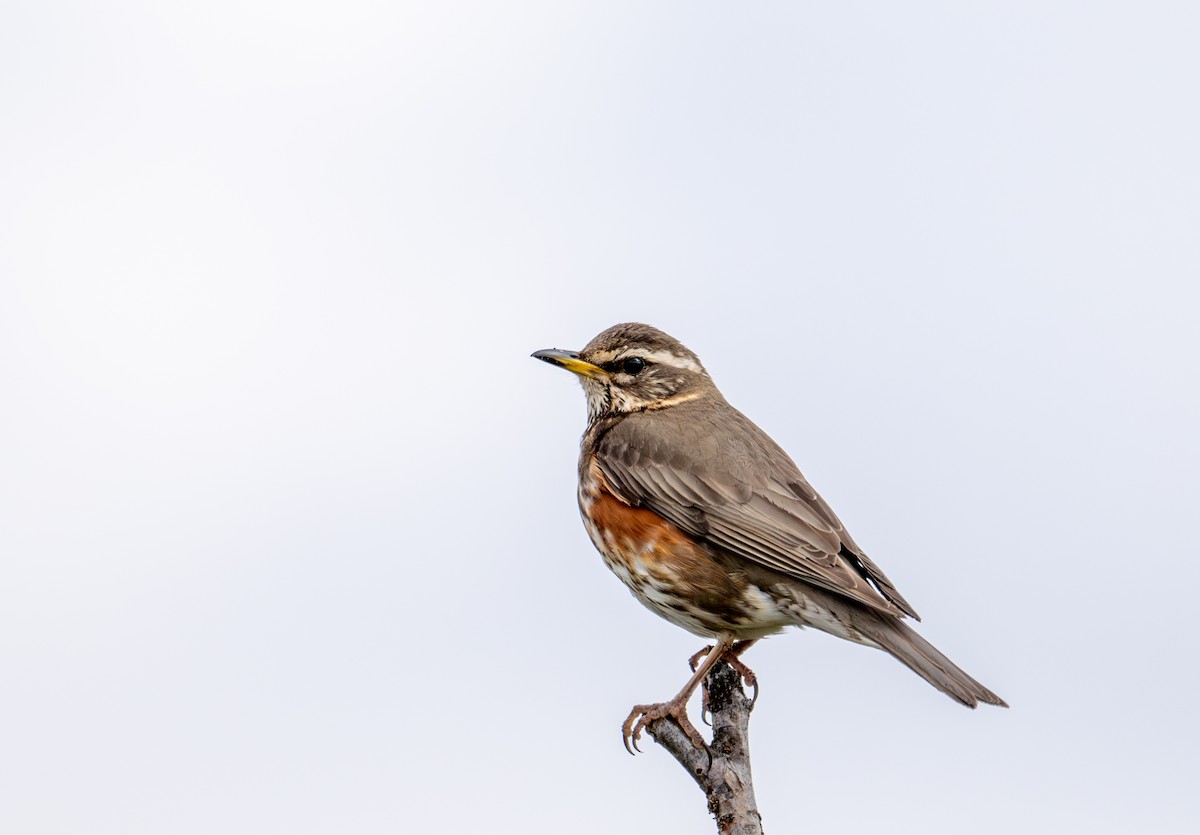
(647, 661, 762, 835)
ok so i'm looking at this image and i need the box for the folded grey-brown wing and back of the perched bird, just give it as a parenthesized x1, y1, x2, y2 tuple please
(594, 395, 919, 620)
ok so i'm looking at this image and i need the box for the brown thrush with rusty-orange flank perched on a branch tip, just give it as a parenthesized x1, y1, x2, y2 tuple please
(532, 323, 1008, 753)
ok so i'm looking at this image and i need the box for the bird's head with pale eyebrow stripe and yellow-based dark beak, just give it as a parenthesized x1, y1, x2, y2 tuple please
(533, 322, 716, 421)
